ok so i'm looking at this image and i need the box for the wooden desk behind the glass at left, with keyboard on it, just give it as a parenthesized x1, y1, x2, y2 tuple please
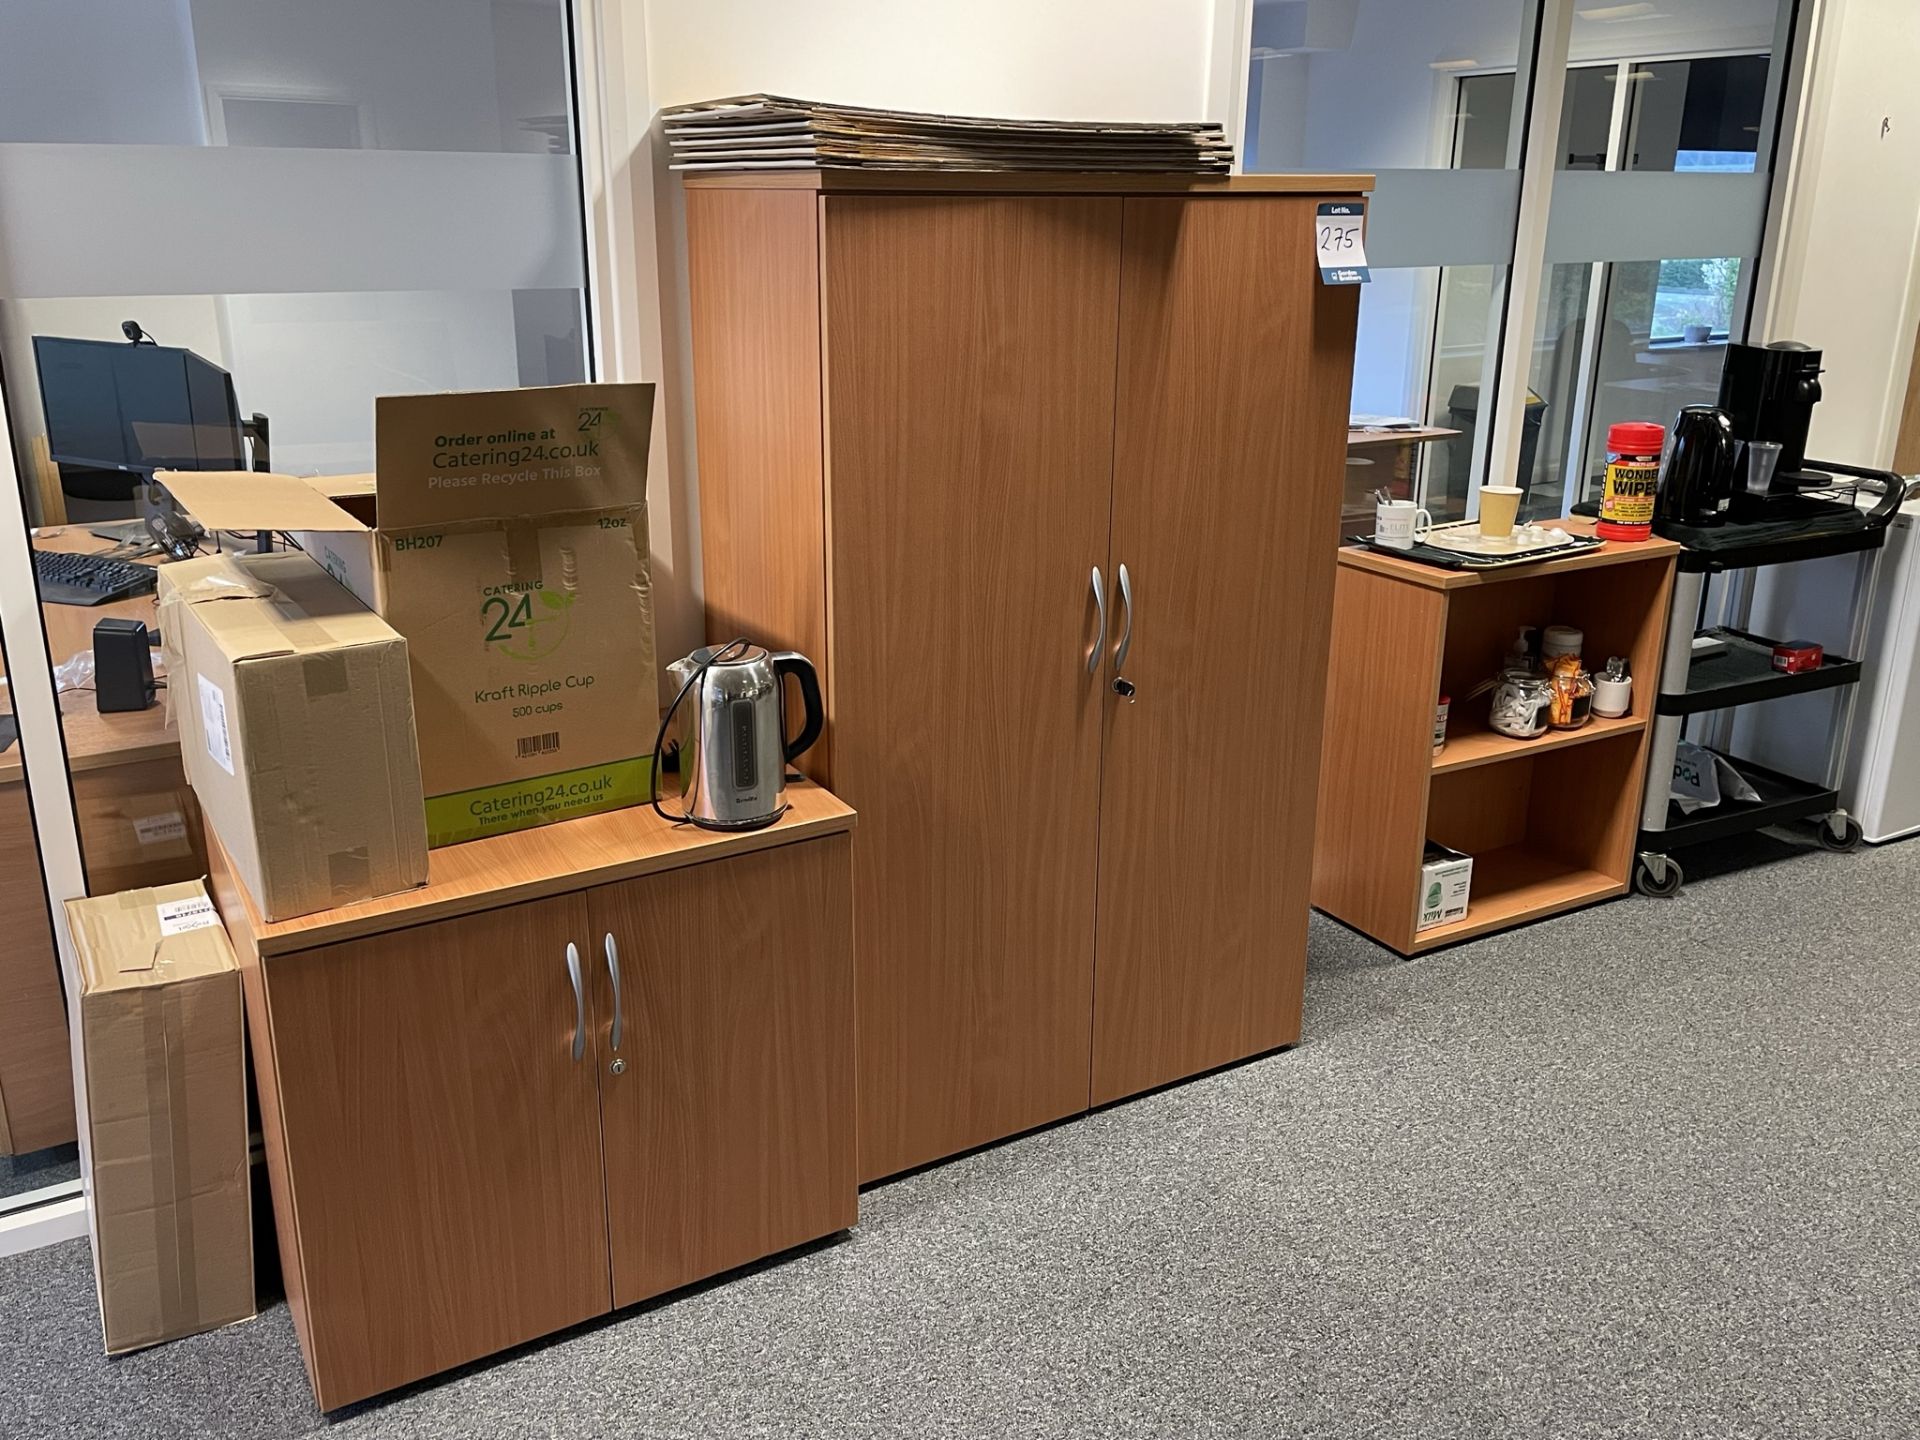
(0, 526, 207, 1154)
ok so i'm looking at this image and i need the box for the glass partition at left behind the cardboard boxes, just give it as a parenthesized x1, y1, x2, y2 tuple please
(0, 0, 591, 1246)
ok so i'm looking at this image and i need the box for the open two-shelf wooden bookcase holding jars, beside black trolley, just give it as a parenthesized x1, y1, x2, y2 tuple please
(1313, 522, 1680, 954)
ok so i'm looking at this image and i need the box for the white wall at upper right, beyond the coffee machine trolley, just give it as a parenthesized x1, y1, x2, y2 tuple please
(1759, 0, 1920, 465)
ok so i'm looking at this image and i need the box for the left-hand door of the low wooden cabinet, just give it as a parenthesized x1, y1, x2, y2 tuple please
(263, 895, 612, 1409)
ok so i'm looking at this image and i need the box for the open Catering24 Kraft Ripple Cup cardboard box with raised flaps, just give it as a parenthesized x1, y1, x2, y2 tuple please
(165, 384, 659, 845)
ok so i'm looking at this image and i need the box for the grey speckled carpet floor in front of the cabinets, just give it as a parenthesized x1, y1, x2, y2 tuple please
(0, 843, 1920, 1440)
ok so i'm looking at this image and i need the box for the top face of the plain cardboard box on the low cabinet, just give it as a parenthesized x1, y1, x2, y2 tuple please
(159, 551, 408, 666)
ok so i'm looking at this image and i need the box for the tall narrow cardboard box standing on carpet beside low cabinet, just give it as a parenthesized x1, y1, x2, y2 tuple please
(67, 879, 253, 1356)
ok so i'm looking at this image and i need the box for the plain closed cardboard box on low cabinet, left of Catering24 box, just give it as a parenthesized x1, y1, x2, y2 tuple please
(159, 551, 426, 920)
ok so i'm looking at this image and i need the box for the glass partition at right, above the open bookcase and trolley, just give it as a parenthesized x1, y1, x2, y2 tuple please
(1244, 0, 1816, 524)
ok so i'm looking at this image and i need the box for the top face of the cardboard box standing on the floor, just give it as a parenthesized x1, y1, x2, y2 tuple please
(67, 879, 234, 995)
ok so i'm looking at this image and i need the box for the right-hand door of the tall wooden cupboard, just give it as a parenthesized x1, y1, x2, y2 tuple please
(1092, 196, 1359, 1104)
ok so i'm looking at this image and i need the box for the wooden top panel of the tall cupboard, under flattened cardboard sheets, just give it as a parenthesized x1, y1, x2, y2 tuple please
(680, 169, 1373, 196)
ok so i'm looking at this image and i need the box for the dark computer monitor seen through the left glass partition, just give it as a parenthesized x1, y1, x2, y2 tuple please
(33, 336, 246, 480)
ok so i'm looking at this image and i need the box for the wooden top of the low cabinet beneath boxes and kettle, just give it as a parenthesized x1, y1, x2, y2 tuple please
(226, 781, 854, 956)
